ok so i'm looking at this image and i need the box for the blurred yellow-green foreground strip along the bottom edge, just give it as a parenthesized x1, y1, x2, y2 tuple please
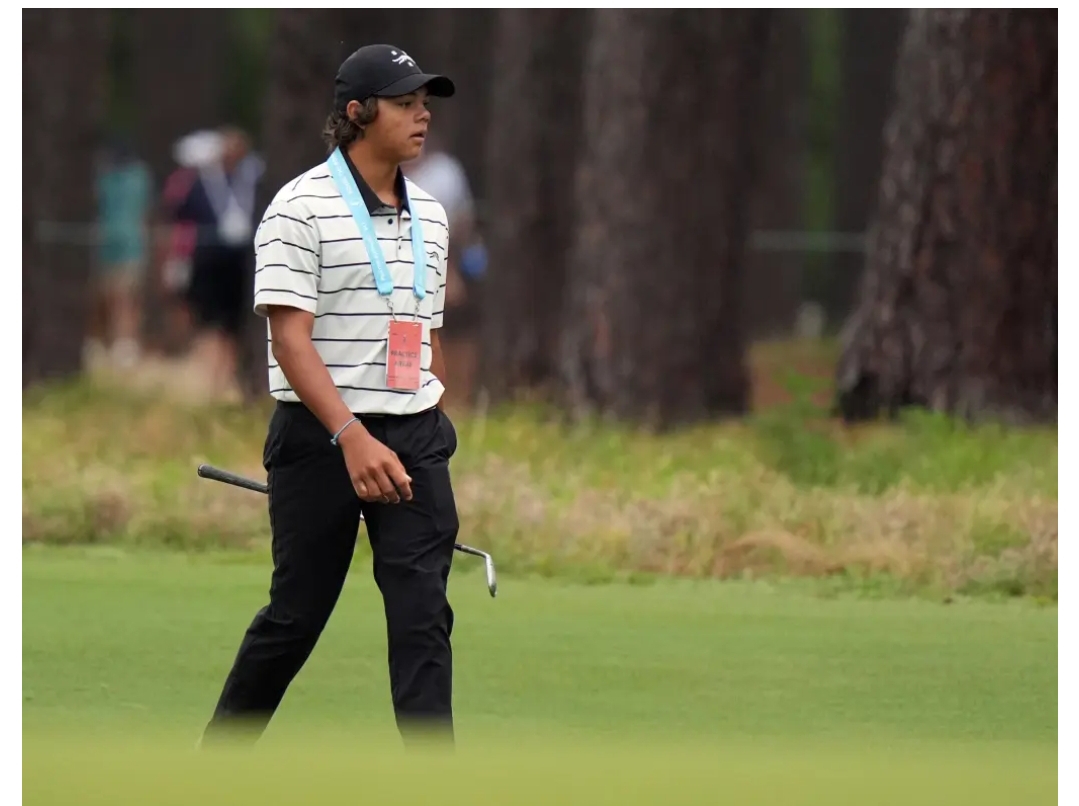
(23, 739, 1056, 806)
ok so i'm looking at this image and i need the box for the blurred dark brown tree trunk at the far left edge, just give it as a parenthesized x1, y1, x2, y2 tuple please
(23, 9, 109, 387)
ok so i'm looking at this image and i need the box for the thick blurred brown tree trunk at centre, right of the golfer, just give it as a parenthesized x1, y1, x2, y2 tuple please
(563, 11, 771, 427)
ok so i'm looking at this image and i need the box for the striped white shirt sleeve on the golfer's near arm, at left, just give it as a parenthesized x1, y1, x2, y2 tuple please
(255, 200, 319, 316)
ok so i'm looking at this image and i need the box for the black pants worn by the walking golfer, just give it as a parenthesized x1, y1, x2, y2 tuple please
(204, 402, 457, 739)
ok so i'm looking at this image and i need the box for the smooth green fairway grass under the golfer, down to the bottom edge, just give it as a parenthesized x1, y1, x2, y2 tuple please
(23, 547, 1056, 804)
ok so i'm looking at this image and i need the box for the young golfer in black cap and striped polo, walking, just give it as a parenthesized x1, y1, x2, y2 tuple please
(205, 45, 457, 741)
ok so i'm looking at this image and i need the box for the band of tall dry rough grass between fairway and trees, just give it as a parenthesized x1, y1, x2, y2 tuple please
(23, 377, 1057, 599)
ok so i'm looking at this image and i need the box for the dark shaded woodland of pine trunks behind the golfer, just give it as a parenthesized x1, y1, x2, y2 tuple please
(23, 10, 1057, 427)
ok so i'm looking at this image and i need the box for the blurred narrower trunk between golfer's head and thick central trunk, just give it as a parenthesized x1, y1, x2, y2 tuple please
(480, 10, 590, 402)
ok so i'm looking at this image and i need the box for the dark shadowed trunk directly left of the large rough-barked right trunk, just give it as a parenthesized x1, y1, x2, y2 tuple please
(822, 9, 907, 330)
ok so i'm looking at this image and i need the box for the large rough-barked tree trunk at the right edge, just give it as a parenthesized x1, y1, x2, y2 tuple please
(837, 10, 1057, 422)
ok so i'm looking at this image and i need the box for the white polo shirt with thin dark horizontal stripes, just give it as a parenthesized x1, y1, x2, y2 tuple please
(255, 158, 449, 414)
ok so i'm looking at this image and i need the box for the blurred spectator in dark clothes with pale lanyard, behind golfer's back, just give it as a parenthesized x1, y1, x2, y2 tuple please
(173, 128, 263, 397)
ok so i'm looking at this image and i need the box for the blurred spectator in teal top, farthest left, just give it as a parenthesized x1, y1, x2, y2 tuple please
(86, 137, 152, 369)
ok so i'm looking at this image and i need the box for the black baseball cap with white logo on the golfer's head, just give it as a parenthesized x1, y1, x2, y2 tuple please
(333, 45, 455, 112)
